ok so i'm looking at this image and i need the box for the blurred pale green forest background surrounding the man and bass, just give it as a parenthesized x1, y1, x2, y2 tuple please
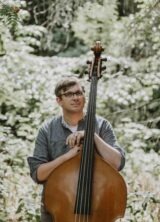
(0, 0, 160, 222)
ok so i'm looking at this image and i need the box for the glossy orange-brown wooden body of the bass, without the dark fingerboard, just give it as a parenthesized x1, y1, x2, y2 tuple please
(44, 154, 127, 222)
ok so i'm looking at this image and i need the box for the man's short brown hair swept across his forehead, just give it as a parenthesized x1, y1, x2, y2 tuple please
(54, 77, 85, 97)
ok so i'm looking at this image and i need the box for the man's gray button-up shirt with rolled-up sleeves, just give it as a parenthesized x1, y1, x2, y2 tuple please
(28, 116, 125, 183)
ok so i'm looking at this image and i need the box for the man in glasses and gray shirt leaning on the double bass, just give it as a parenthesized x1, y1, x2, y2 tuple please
(28, 78, 125, 222)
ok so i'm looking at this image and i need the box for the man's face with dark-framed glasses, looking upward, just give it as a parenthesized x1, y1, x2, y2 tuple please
(57, 84, 85, 113)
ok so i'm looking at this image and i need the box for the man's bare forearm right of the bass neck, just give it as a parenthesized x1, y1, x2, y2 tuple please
(94, 133, 121, 170)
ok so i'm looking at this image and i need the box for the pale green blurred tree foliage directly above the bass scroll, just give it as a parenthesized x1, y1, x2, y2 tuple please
(72, 0, 117, 49)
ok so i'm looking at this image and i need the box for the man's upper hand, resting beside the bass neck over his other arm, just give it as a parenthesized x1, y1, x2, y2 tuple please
(66, 130, 84, 148)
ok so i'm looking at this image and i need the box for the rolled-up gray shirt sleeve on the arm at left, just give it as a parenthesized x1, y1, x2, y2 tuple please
(27, 125, 49, 183)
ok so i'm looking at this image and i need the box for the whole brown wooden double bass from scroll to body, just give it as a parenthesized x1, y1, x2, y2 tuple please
(44, 41, 127, 222)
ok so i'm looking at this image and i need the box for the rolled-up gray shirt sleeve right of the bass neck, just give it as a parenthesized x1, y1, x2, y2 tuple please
(99, 120, 125, 171)
